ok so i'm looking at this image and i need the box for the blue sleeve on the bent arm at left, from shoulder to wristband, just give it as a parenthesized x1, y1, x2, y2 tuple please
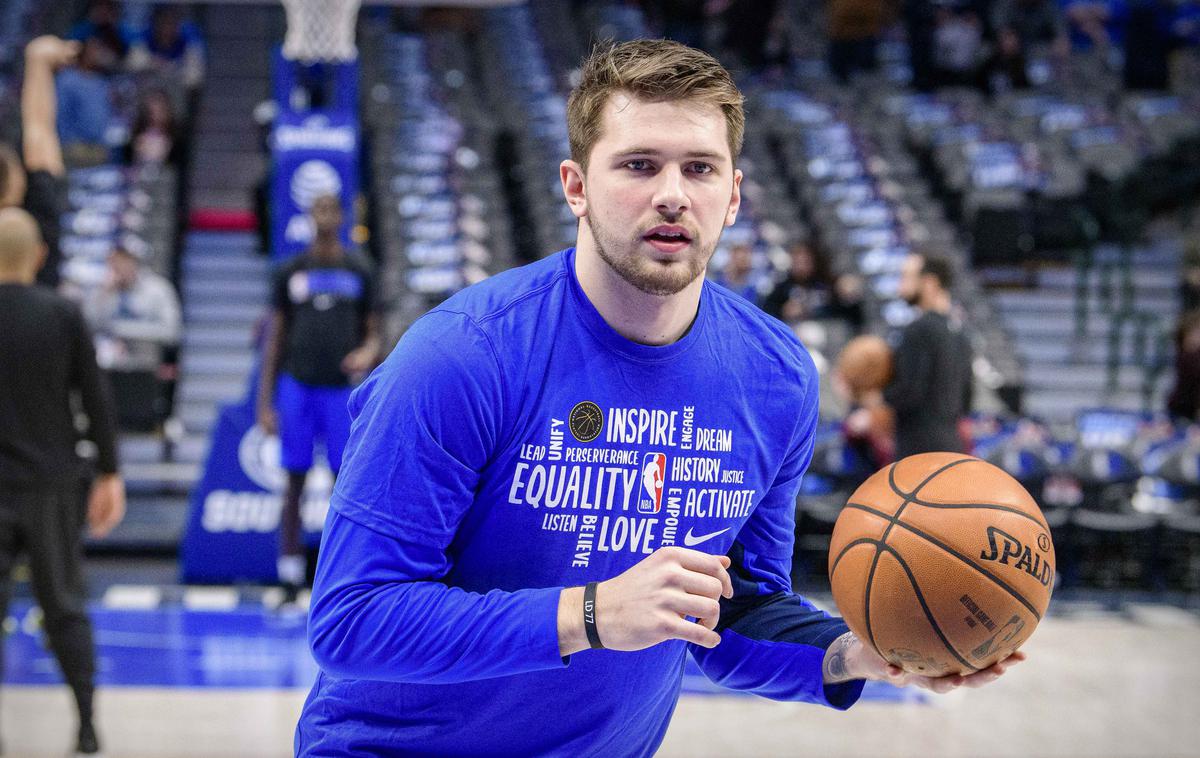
(308, 311, 566, 684)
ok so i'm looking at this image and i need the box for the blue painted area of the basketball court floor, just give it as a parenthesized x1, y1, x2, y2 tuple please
(4, 601, 925, 703)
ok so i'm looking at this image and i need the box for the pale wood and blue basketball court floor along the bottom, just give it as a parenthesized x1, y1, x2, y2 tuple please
(0, 558, 1200, 758)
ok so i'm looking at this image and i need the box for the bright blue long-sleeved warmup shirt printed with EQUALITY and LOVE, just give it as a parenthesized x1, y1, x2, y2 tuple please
(295, 249, 863, 758)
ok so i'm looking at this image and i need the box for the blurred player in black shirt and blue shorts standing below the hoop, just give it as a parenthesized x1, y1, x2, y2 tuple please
(258, 195, 379, 602)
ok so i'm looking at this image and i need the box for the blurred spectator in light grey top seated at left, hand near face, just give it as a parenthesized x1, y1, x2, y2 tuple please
(84, 246, 182, 371)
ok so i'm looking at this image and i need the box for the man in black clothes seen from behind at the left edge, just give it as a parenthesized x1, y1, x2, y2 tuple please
(0, 207, 125, 754)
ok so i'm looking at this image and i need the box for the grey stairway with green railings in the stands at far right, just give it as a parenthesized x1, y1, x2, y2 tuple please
(984, 240, 1180, 421)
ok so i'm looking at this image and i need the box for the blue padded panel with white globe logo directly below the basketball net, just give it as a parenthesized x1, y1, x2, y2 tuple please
(271, 110, 360, 261)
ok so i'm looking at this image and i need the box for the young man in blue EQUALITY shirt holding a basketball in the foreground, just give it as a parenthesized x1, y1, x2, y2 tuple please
(295, 41, 1017, 756)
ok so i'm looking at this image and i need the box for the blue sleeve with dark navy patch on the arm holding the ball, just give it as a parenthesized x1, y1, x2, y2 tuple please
(690, 362, 864, 710)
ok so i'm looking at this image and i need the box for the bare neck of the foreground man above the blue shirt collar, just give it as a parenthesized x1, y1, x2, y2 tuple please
(575, 223, 704, 345)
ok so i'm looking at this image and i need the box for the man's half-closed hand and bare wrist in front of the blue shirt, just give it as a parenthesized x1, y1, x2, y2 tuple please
(558, 547, 733, 656)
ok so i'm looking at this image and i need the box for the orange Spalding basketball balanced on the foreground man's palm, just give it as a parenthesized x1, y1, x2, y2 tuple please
(829, 452, 1055, 676)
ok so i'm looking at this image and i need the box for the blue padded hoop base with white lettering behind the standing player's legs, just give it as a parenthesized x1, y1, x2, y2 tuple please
(180, 371, 332, 584)
